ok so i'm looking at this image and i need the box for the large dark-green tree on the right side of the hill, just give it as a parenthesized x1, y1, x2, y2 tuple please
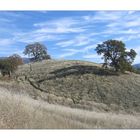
(95, 40, 137, 72)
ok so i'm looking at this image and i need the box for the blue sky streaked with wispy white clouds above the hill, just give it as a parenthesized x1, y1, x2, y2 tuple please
(0, 11, 140, 64)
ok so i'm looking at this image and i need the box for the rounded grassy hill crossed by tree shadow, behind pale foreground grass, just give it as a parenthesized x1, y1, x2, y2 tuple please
(16, 60, 140, 113)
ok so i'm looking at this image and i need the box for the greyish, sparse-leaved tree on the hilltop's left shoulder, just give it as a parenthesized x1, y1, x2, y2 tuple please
(23, 42, 51, 61)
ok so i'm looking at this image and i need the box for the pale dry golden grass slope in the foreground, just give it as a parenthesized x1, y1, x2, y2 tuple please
(0, 86, 140, 129)
